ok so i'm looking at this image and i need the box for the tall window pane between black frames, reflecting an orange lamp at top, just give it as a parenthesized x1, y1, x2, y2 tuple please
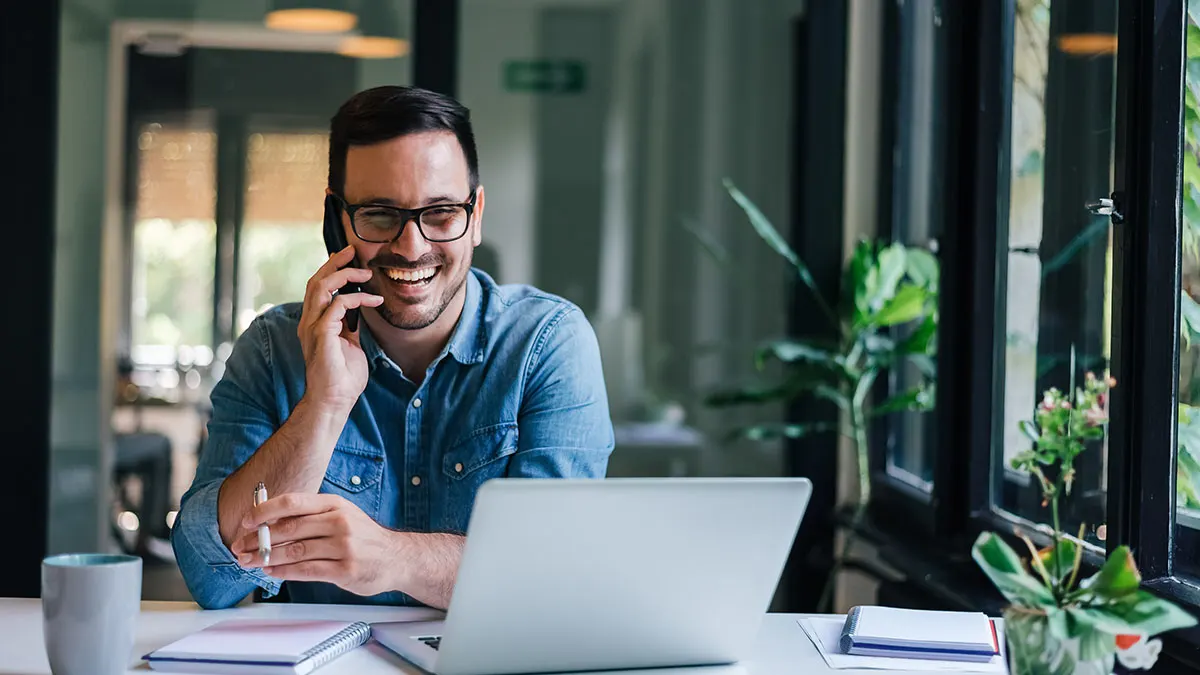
(992, 0, 1117, 545)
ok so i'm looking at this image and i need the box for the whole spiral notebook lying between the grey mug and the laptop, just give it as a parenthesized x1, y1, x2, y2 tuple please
(142, 619, 371, 675)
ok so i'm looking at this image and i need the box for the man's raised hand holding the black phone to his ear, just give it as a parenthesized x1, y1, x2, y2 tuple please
(296, 246, 383, 414)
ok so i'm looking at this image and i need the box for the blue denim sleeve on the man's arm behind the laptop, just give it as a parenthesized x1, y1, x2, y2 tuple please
(508, 306, 613, 478)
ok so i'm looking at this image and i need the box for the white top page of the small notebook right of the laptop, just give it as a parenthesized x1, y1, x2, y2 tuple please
(854, 607, 994, 650)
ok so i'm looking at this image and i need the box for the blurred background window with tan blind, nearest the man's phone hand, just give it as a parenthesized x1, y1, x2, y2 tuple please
(236, 132, 329, 333)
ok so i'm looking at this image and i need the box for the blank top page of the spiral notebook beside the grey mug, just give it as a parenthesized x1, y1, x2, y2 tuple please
(154, 619, 352, 663)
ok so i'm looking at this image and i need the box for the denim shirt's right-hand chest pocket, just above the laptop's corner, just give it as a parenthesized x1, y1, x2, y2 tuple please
(442, 423, 517, 532)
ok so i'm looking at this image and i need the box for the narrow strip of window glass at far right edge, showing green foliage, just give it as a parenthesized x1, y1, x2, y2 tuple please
(1175, 6, 1200, 566)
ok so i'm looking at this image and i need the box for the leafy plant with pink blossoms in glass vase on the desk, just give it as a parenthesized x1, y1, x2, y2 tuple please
(971, 372, 1196, 675)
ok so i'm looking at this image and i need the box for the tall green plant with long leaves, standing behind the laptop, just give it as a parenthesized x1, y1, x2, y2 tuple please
(692, 180, 938, 611)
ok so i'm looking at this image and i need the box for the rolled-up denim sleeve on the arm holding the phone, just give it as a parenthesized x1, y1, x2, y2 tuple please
(170, 317, 281, 609)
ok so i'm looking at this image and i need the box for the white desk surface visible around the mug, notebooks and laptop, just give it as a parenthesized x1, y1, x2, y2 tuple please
(0, 598, 984, 675)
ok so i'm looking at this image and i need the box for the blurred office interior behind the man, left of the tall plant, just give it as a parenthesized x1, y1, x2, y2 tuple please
(32, 0, 816, 598)
